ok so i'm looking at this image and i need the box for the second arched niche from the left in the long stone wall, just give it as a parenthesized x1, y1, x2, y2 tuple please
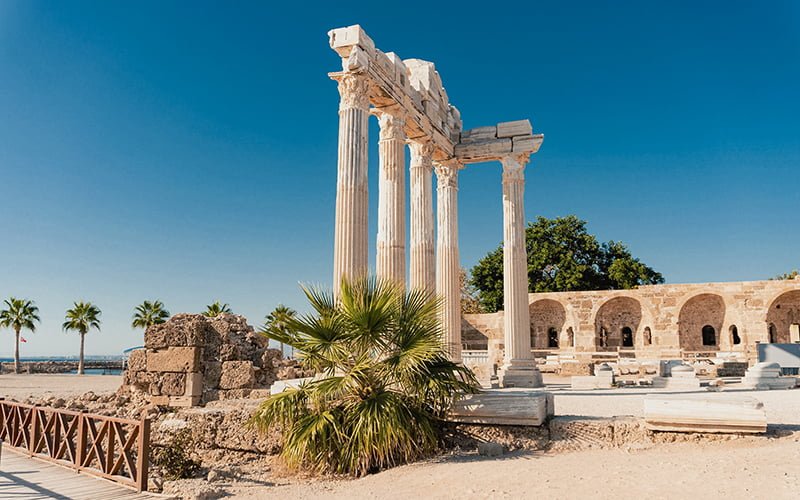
(594, 297, 642, 351)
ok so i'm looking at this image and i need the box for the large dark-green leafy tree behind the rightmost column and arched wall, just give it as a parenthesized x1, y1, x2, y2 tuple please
(471, 215, 664, 312)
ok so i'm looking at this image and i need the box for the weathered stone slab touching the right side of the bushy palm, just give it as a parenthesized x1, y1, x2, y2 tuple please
(448, 388, 555, 426)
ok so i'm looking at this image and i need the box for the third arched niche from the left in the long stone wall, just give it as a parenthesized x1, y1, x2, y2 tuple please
(678, 293, 726, 351)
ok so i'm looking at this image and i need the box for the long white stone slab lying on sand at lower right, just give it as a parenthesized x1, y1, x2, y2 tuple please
(644, 393, 767, 433)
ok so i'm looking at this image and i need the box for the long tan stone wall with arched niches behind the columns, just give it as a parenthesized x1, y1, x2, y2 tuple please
(465, 279, 800, 357)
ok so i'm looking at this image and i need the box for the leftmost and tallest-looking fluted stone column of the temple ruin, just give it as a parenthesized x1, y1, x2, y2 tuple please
(333, 74, 369, 296)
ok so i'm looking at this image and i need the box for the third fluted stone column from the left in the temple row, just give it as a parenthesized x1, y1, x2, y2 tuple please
(409, 141, 436, 294)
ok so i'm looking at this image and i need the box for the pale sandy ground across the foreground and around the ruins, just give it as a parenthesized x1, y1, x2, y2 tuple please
(0, 374, 800, 500)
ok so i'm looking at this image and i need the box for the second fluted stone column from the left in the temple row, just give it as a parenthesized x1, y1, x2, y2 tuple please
(375, 110, 406, 287)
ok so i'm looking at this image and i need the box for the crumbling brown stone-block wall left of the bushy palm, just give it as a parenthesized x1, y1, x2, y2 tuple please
(123, 314, 306, 406)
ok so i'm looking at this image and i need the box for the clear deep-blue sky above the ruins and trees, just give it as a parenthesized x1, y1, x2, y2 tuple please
(0, 0, 800, 356)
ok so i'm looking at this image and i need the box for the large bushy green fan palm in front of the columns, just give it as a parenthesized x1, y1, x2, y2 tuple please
(251, 278, 478, 475)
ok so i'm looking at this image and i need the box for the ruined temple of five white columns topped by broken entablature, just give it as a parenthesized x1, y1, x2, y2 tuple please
(328, 25, 544, 387)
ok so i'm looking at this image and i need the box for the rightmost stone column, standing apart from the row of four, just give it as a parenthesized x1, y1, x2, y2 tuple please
(500, 154, 542, 387)
